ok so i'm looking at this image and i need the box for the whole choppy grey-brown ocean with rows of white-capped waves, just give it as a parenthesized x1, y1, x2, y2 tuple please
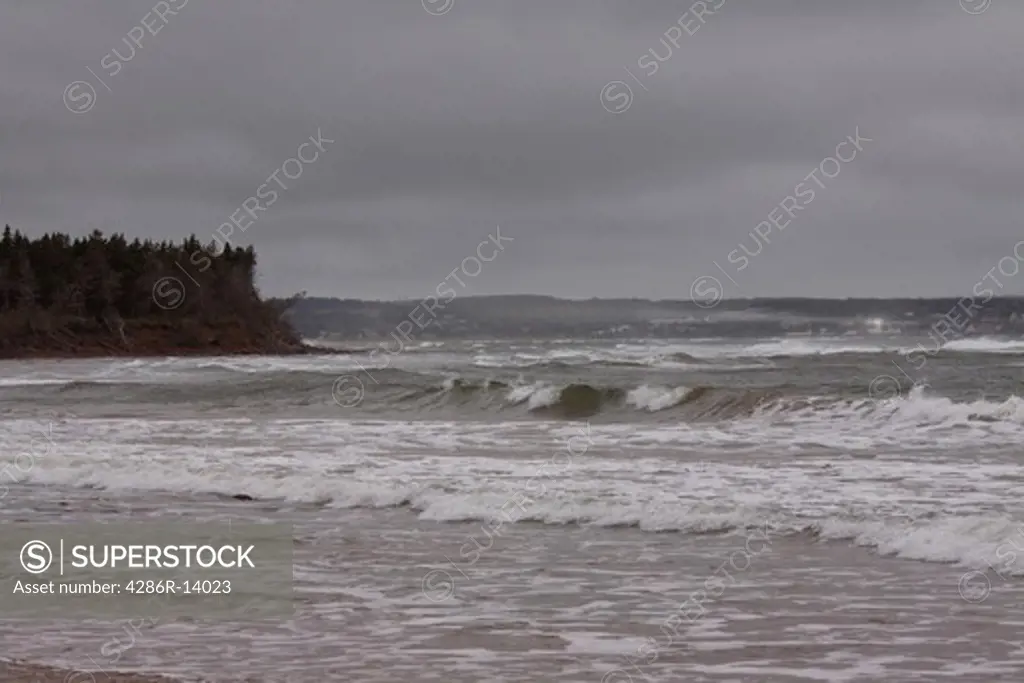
(0, 322, 1024, 683)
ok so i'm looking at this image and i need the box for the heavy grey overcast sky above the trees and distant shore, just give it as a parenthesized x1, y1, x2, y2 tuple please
(0, 0, 1024, 298)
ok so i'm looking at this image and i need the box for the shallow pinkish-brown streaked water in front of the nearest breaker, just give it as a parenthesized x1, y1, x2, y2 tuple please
(0, 499, 1024, 683)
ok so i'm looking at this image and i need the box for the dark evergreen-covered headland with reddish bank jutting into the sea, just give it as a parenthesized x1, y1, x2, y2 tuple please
(0, 225, 304, 357)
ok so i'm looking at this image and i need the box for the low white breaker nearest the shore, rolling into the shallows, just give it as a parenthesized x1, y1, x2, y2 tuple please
(22, 462, 1024, 577)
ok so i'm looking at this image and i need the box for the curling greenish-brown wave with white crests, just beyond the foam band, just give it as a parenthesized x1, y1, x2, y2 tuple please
(6, 362, 1024, 427)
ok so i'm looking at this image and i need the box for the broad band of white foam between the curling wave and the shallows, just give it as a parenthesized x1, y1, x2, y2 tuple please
(12, 417, 1024, 574)
